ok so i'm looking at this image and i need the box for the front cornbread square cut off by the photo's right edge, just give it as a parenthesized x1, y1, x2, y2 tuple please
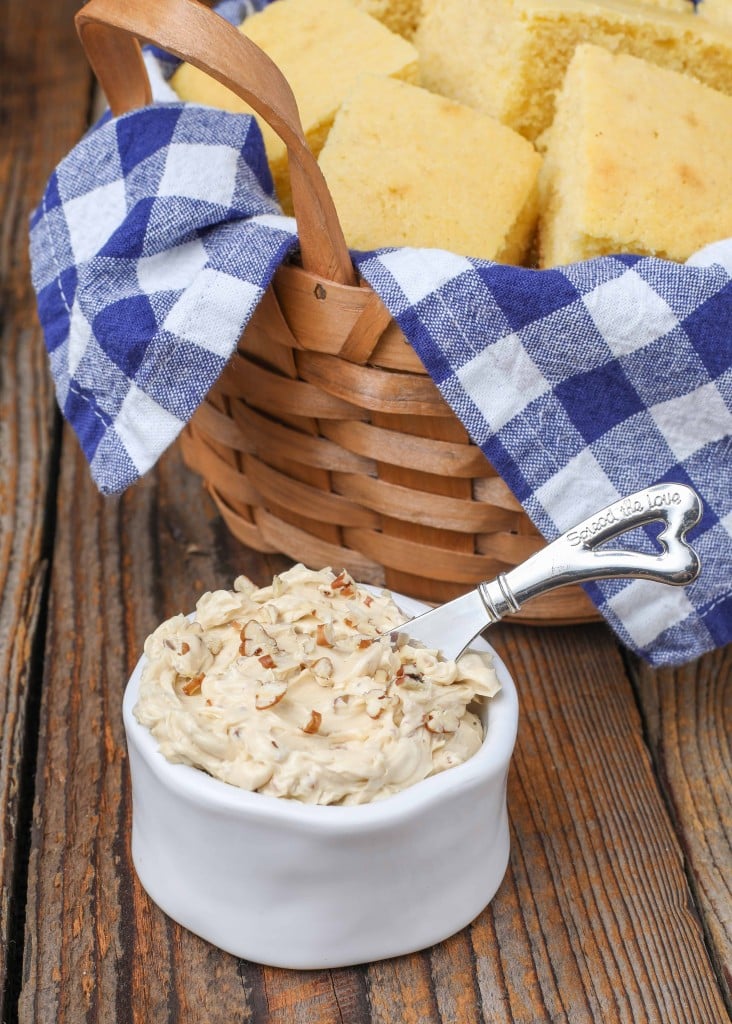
(540, 44, 732, 266)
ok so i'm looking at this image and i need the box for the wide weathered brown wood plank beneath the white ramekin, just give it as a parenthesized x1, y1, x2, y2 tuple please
(19, 435, 724, 1024)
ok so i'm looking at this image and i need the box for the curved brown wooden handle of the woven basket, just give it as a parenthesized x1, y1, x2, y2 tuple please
(75, 0, 355, 285)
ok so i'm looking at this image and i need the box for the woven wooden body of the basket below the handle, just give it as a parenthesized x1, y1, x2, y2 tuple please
(182, 266, 595, 622)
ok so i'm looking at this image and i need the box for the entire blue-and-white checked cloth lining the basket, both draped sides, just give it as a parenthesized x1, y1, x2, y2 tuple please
(31, 6, 732, 665)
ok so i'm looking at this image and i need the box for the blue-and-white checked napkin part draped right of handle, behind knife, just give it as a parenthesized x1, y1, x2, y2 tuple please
(357, 240, 732, 665)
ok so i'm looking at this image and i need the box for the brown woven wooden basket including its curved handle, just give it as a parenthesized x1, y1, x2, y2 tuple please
(77, 0, 598, 624)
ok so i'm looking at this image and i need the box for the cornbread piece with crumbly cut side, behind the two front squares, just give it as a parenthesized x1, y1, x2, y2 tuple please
(415, 0, 732, 147)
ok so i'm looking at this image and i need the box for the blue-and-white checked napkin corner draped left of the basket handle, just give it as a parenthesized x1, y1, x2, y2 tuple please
(31, 103, 296, 493)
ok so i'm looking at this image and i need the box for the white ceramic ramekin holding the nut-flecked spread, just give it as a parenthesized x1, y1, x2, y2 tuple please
(124, 594, 518, 969)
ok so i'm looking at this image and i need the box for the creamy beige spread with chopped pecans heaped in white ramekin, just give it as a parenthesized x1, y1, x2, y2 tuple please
(135, 565, 500, 804)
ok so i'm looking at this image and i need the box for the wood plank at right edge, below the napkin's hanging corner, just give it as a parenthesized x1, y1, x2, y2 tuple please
(633, 646, 732, 1008)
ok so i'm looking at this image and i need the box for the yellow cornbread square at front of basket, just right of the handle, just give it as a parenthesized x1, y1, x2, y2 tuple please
(319, 75, 542, 263)
